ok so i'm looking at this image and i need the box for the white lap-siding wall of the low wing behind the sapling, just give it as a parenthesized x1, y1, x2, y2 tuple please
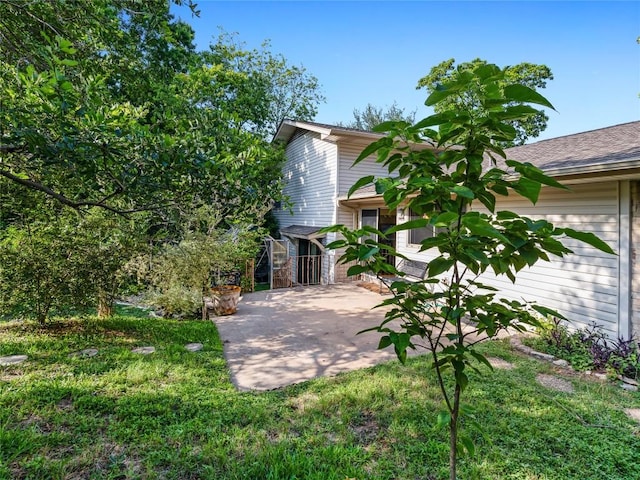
(397, 182, 620, 337)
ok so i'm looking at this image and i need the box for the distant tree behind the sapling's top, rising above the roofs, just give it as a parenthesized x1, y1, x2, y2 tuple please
(416, 58, 553, 147)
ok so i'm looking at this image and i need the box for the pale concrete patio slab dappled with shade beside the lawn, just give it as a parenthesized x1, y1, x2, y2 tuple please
(214, 284, 500, 390)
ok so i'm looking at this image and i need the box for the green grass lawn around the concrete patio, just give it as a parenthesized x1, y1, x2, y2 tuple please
(0, 309, 640, 480)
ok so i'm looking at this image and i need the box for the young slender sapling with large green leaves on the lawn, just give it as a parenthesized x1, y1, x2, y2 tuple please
(329, 63, 613, 480)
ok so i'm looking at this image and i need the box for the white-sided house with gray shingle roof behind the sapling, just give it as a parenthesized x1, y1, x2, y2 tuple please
(275, 120, 640, 338)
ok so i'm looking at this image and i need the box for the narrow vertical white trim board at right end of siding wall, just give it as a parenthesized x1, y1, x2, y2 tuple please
(617, 180, 631, 339)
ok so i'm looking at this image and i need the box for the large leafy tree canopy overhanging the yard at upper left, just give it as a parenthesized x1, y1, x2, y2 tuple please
(0, 0, 321, 322)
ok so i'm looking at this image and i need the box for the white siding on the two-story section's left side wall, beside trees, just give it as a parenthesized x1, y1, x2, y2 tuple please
(274, 132, 337, 228)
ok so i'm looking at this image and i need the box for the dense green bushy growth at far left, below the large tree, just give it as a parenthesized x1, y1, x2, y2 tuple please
(0, 197, 147, 324)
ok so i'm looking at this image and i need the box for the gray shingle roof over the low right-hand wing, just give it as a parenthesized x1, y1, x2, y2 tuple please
(506, 121, 640, 170)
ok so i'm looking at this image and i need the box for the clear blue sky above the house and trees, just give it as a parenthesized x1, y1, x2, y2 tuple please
(174, 0, 640, 139)
